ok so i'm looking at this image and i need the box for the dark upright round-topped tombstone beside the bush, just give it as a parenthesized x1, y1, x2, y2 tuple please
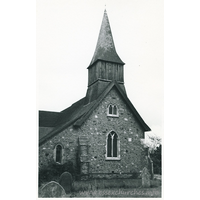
(59, 172, 73, 194)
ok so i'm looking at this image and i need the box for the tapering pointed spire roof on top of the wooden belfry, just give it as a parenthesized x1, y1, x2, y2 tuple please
(89, 10, 124, 67)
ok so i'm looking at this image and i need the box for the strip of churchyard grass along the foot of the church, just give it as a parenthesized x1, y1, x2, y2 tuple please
(39, 178, 161, 198)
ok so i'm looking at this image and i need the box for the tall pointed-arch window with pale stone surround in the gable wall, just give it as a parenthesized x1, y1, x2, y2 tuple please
(106, 131, 120, 160)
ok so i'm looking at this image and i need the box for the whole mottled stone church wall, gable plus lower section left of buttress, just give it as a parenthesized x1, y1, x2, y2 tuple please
(39, 88, 147, 177)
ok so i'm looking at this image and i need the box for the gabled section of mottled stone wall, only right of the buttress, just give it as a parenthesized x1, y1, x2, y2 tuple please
(82, 89, 146, 176)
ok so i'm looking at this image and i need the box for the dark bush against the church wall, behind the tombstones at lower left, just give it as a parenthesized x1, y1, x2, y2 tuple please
(39, 161, 75, 187)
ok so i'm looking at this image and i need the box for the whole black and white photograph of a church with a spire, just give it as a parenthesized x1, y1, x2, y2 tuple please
(36, 0, 164, 198)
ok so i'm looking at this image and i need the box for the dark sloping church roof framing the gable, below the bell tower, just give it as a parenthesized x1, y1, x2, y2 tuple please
(39, 81, 151, 145)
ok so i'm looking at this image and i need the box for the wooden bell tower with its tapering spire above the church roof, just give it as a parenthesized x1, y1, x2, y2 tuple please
(85, 10, 126, 104)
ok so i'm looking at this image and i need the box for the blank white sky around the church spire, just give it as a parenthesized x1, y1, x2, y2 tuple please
(36, 0, 164, 136)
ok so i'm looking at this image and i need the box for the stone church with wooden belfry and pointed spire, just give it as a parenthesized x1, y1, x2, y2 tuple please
(39, 10, 151, 178)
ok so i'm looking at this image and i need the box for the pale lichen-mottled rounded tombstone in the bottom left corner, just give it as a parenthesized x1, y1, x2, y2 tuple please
(39, 181, 67, 198)
